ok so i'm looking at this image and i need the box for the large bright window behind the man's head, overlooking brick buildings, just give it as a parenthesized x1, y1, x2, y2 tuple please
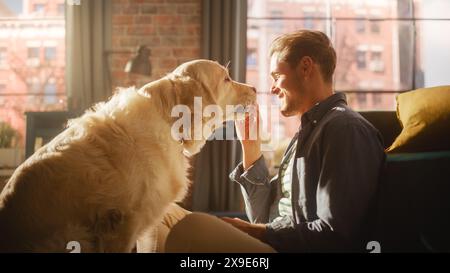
(246, 0, 450, 147)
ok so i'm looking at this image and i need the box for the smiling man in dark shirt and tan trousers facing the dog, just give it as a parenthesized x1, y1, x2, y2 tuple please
(139, 30, 384, 252)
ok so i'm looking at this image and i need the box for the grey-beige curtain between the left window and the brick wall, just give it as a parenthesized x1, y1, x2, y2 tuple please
(66, 0, 112, 111)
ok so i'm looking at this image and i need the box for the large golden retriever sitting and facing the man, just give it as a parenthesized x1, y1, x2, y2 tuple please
(0, 60, 256, 252)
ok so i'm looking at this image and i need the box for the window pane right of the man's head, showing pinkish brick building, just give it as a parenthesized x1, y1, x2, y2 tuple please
(334, 20, 414, 91)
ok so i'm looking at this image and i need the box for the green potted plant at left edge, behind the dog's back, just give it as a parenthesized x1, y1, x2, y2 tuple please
(0, 122, 23, 169)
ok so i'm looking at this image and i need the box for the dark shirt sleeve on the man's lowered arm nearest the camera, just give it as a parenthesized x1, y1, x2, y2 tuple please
(267, 120, 384, 252)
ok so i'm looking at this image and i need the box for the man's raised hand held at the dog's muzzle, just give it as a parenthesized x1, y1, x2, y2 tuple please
(235, 105, 262, 170)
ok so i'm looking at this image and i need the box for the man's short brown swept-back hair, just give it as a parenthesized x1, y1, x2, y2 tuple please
(270, 30, 336, 83)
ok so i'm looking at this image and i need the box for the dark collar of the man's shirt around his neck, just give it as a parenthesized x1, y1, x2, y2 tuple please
(301, 92, 347, 128)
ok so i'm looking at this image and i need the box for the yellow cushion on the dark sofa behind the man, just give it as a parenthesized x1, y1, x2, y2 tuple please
(386, 86, 450, 153)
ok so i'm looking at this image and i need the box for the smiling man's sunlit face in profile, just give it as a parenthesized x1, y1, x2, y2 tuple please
(270, 53, 304, 117)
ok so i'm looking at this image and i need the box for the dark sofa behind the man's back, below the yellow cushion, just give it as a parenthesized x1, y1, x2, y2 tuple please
(361, 111, 450, 252)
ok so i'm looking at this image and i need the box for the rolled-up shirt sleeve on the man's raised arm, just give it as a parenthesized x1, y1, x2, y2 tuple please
(230, 156, 271, 223)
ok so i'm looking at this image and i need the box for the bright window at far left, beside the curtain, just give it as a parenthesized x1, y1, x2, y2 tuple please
(0, 0, 66, 147)
